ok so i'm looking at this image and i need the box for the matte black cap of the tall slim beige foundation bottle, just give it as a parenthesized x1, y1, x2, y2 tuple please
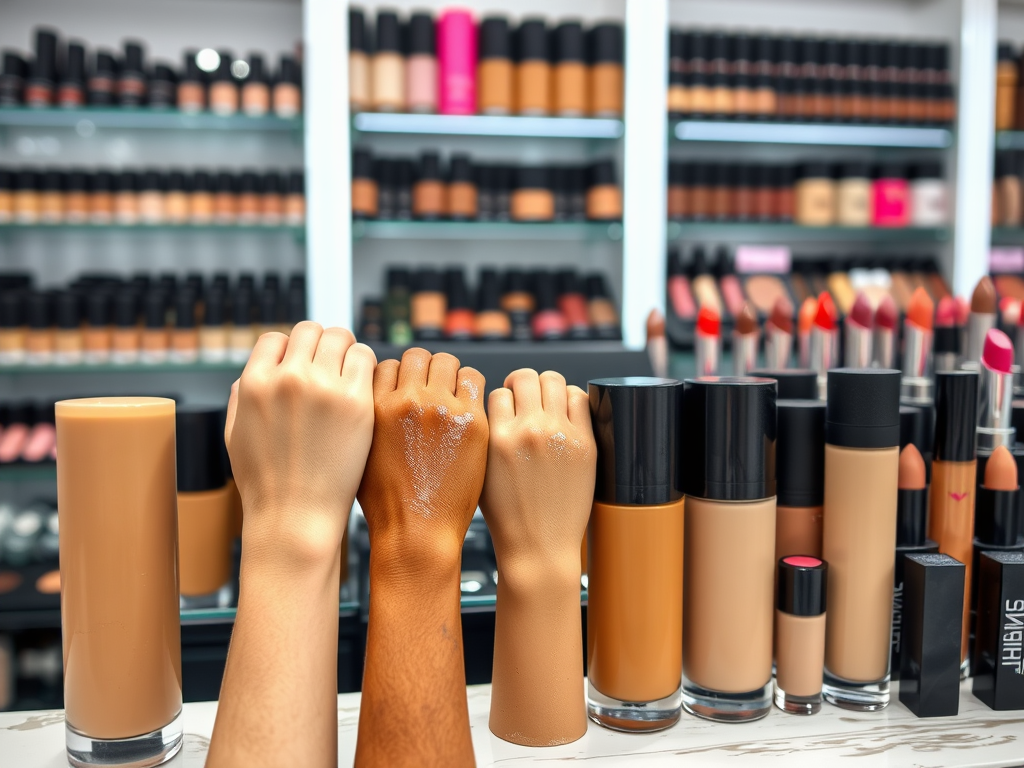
(825, 368, 900, 449)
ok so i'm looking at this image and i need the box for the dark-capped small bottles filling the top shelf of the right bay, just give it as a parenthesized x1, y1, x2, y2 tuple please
(668, 30, 956, 124)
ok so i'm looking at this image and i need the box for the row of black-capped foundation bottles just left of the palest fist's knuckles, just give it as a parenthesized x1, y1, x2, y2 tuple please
(0, 272, 306, 367)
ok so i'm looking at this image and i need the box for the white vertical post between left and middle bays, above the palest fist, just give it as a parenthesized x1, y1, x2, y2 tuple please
(303, 0, 353, 328)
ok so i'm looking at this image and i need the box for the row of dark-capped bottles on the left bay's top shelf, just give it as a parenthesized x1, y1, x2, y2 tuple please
(0, 29, 302, 118)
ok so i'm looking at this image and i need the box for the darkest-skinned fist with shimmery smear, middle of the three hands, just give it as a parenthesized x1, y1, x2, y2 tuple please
(358, 348, 487, 567)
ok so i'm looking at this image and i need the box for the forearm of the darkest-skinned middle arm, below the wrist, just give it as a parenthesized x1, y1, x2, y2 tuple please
(355, 545, 474, 768)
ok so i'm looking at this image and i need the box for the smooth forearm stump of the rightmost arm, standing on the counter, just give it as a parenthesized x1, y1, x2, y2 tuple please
(490, 552, 587, 746)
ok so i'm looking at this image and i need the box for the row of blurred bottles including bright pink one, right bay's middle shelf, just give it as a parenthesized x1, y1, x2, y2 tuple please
(668, 160, 948, 227)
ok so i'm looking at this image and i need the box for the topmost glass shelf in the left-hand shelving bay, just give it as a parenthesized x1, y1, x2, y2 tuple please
(0, 106, 302, 135)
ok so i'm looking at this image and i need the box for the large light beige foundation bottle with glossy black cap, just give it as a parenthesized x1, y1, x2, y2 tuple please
(681, 376, 776, 722)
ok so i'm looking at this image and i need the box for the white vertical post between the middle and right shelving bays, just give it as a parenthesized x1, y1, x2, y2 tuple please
(623, 0, 667, 349)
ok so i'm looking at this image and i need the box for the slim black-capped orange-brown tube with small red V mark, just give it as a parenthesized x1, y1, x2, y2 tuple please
(928, 371, 978, 672)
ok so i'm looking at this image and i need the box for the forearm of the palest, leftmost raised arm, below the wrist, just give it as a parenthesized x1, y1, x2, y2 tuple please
(207, 540, 341, 768)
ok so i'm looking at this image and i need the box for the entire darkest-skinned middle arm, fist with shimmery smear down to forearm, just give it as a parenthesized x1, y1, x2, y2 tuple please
(355, 349, 487, 768)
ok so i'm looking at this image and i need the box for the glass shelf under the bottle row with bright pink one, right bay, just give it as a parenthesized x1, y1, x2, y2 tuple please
(666, 221, 950, 243)
